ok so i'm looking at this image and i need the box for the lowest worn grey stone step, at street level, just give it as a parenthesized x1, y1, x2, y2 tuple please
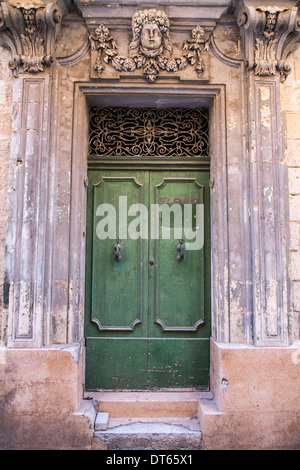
(94, 418, 202, 452)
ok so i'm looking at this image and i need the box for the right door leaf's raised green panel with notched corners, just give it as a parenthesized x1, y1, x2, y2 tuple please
(150, 173, 205, 332)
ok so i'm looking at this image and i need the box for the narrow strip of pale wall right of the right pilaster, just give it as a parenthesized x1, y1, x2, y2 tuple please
(281, 49, 300, 340)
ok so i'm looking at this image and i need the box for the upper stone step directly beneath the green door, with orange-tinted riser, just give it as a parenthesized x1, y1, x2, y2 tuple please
(85, 391, 210, 418)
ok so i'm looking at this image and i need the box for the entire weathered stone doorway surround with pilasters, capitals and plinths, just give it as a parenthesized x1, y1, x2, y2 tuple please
(0, 0, 300, 449)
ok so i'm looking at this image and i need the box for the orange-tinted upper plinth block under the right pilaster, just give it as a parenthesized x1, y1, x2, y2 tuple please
(211, 341, 300, 414)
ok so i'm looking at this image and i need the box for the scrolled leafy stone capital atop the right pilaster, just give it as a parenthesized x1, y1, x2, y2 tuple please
(237, 4, 300, 80)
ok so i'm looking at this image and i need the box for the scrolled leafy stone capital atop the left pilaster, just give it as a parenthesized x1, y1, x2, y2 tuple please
(0, 0, 61, 77)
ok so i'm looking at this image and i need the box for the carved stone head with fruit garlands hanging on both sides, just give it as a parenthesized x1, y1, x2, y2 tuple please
(90, 9, 210, 83)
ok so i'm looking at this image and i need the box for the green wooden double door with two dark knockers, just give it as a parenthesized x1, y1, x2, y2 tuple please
(85, 170, 210, 390)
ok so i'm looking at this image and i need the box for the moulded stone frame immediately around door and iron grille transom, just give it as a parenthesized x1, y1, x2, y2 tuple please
(69, 83, 229, 390)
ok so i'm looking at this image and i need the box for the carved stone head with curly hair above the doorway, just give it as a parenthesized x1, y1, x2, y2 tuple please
(130, 9, 171, 57)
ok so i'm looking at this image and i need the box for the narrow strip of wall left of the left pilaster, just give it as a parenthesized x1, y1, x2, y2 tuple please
(0, 46, 13, 345)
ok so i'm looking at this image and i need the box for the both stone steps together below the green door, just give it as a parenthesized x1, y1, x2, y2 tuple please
(85, 391, 212, 450)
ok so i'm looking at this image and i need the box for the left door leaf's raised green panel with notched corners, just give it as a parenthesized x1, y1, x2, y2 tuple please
(91, 173, 148, 331)
